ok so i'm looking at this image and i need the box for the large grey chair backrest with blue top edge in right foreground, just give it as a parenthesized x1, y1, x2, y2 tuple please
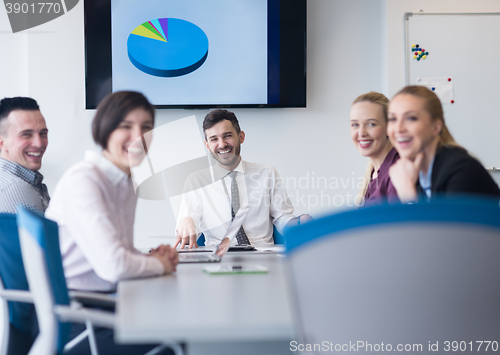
(286, 201, 500, 353)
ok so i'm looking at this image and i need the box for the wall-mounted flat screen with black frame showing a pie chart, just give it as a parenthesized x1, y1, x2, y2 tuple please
(84, 0, 306, 109)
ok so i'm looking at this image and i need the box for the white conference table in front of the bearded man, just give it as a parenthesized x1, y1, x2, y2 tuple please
(115, 251, 295, 355)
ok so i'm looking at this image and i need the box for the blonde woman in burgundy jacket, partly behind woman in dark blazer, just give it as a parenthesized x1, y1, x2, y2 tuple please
(350, 91, 399, 205)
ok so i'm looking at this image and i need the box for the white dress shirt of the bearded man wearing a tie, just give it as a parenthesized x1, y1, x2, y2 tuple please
(178, 160, 295, 246)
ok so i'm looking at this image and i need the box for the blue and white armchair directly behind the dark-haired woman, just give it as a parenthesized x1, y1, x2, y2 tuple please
(17, 207, 183, 355)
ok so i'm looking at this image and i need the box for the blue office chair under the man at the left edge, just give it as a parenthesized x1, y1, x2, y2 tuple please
(0, 213, 38, 355)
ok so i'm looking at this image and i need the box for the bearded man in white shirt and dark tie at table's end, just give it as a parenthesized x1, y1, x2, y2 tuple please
(175, 109, 311, 248)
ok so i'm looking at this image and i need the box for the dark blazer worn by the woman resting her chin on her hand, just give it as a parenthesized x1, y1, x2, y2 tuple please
(419, 147, 500, 198)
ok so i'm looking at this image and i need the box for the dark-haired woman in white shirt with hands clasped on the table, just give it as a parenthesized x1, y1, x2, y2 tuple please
(46, 91, 178, 354)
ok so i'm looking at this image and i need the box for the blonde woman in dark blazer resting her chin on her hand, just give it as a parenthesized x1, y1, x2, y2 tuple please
(387, 86, 500, 203)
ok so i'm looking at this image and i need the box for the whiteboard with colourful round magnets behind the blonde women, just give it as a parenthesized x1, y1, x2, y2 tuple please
(405, 13, 500, 168)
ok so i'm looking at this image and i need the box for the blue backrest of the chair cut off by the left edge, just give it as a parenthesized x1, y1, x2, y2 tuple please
(0, 213, 37, 337)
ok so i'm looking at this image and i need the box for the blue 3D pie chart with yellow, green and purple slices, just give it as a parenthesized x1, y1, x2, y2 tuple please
(127, 18, 208, 77)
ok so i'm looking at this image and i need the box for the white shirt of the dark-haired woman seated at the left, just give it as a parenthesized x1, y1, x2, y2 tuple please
(45, 152, 164, 291)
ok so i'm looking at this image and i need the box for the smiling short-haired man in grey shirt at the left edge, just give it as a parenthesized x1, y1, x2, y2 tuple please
(0, 97, 50, 213)
